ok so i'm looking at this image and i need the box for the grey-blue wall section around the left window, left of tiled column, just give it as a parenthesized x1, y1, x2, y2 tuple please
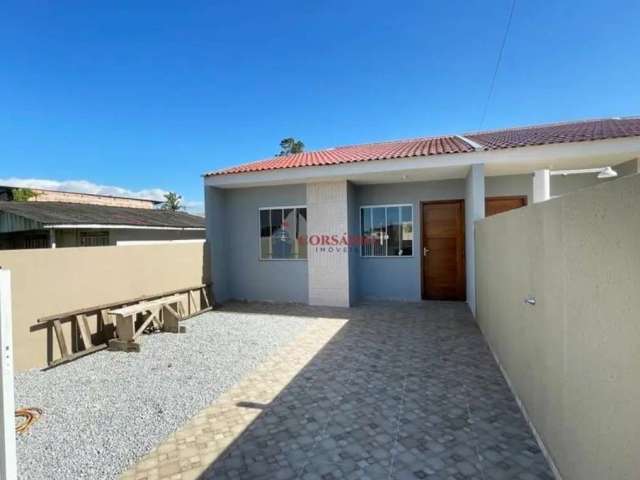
(205, 185, 308, 303)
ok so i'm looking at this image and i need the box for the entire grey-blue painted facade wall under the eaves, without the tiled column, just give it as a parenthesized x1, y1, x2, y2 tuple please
(205, 161, 637, 303)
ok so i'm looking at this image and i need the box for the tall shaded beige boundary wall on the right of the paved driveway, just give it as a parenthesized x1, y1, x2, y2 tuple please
(476, 175, 640, 480)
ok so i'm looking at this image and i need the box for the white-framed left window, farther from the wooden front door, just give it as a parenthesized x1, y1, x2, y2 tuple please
(260, 207, 307, 260)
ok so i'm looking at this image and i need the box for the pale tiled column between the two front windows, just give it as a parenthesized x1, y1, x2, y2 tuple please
(307, 180, 351, 307)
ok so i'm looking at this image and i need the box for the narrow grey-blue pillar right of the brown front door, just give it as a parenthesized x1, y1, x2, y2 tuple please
(464, 164, 485, 316)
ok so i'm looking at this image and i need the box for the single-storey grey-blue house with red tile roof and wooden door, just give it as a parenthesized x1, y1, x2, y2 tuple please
(204, 118, 640, 312)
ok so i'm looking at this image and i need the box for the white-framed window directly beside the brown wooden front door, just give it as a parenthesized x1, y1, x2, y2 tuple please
(360, 205, 413, 257)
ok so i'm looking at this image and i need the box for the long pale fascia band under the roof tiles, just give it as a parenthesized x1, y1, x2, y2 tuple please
(204, 137, 640, 188)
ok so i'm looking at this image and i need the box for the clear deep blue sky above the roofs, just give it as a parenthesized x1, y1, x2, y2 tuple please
(0, 0, 640, 210)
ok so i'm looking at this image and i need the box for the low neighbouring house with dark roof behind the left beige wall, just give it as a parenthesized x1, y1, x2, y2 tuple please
(0, 201, 205, 250)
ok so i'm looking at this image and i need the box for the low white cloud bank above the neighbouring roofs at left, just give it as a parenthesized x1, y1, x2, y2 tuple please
(0, 177, 204, 212)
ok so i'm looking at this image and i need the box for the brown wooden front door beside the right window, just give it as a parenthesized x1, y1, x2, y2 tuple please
(420, 200, 466, 300)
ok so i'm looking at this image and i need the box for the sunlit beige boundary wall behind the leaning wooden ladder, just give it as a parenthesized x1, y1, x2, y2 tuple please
(0, 243, 206, 371)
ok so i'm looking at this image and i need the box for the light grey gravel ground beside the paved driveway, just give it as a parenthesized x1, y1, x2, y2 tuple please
(15, 307, 312, 480)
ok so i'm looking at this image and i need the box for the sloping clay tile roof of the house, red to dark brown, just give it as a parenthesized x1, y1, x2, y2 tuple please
(207, 118, 640, 175)
